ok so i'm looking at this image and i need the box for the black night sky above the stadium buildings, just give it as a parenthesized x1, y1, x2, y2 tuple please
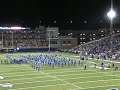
(0, 0, 120, 29)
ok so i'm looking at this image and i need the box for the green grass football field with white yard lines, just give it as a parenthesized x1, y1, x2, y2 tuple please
(0, 52, 120, 90)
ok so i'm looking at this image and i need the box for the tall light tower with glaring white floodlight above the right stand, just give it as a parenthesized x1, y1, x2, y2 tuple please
(107, 0, 116, 56)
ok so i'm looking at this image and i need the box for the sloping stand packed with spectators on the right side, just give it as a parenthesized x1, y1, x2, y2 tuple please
(69, 33, 120, 54)
